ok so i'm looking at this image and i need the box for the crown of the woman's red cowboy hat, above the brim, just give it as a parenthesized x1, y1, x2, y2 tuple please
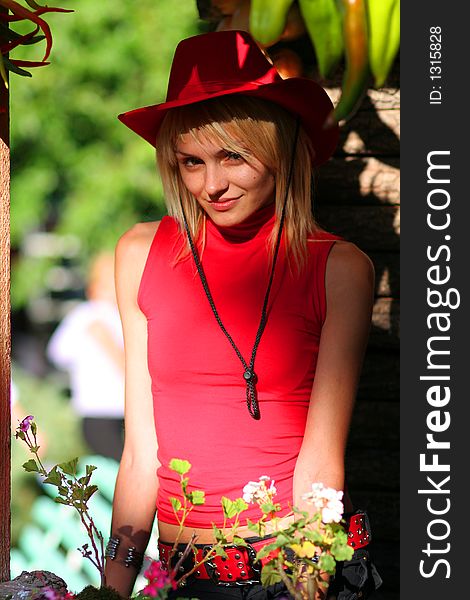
(167, 31, 282, 102)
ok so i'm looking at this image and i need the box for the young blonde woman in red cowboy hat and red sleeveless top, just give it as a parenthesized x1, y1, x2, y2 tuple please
(106, 31, 374, 599)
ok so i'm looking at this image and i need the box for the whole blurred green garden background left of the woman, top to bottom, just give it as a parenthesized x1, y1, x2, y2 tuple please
(10, 0, 208, 592)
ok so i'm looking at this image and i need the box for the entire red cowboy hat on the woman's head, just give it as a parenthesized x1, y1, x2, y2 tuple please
(118, 31, 338, 166)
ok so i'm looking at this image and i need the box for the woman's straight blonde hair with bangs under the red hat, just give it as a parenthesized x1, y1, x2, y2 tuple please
(156, 95, 318, 268)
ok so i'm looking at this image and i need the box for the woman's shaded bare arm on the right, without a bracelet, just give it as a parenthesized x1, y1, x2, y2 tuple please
(293, 242, 374, 510)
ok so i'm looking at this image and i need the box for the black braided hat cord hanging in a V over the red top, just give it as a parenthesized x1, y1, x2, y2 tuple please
(180, 119, 300, 420)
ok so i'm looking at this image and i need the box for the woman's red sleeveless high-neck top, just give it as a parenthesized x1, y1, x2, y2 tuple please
(138, 206, 339, 528)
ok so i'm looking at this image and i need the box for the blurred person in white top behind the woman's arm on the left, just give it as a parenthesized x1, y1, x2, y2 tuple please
(47, 252, 124, 460)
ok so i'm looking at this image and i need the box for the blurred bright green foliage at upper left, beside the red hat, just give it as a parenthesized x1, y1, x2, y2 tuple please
(11, 0, 206, 307)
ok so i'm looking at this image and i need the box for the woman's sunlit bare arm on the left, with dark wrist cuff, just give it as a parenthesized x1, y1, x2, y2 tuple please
(105, 223, 159, 598)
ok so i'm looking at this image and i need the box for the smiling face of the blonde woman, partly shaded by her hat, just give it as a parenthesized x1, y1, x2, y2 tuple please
(176, 134, 275, 227)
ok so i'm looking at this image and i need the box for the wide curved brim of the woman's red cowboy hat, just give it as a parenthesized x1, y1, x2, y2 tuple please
(118, 77, 339, 166)
